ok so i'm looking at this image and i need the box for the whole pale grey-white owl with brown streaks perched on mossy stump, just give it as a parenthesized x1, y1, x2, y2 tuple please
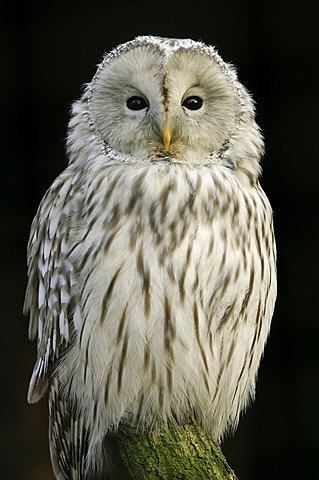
(25, 36, 276, 480)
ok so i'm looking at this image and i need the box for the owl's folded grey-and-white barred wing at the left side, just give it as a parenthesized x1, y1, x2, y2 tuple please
(24, 169, 81, 403)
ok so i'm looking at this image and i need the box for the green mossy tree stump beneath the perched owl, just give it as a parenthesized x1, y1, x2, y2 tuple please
(116, 425, 236, 480)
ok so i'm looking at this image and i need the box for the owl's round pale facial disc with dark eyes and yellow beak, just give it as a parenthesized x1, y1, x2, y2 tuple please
(91, 44, 240, 164)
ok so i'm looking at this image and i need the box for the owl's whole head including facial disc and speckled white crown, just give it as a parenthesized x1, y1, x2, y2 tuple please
(68, 36, 263, 182)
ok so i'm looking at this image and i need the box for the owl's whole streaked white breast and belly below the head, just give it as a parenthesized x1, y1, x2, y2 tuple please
(57, 163, 274, 442)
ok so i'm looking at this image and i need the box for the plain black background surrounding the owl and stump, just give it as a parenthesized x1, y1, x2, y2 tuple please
(0, 0, 319, 480)
